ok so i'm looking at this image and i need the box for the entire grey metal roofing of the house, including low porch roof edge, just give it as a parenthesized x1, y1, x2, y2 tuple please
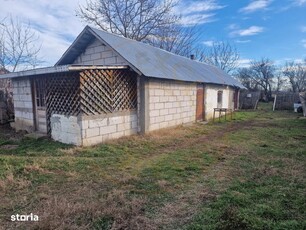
(0, 26, 244, 88)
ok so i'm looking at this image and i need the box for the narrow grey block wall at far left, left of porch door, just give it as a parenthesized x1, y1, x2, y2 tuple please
(12, 78, 34, 132)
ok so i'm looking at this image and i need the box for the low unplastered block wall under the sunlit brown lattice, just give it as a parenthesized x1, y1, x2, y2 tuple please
(80, 111, 138, 146)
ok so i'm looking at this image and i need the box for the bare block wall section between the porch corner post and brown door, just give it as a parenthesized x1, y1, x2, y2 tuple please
(147, 79, 197, 131)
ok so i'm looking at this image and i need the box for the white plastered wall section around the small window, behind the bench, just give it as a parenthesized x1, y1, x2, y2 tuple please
(204, 84, 235, 120)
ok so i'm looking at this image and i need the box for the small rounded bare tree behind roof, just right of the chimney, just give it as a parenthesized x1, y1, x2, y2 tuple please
(200, 41, 239, 73)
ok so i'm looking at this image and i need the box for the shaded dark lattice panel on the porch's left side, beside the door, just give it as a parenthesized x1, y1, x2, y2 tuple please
(46, 73, 80, 134)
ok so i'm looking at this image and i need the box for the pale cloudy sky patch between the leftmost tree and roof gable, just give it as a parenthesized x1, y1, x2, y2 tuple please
(0, 0, 86, 65)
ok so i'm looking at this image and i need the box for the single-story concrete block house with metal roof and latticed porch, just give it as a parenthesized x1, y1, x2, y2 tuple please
(1, 26, 242, 146)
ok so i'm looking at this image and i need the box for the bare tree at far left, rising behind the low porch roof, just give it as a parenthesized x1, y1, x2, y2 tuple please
(0, 17, 41, 72)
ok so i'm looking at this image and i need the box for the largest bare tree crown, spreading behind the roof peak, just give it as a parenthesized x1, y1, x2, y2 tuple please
(77, 0, 180, 41)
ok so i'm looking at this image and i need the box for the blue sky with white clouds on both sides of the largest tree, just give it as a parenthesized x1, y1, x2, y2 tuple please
(0, 0, 306, 66)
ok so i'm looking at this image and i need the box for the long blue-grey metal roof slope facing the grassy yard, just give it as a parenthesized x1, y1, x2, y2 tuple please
(85, 27, 243, 88)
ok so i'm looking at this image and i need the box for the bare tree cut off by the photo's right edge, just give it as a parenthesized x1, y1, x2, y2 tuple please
(283, 58, 306, 92)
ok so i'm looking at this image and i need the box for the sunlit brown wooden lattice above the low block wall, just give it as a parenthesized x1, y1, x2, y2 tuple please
(80, 69, 137, 115)
